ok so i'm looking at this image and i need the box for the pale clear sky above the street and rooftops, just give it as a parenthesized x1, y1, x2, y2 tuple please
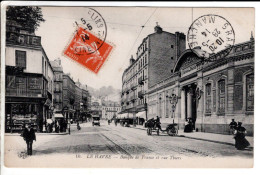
(35, 7, 255, 89)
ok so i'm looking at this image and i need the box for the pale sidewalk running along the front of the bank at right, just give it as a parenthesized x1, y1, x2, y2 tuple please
(130, 125, 254, 148)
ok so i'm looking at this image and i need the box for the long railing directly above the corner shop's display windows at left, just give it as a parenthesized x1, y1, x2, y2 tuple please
(6, 88, 47, 97)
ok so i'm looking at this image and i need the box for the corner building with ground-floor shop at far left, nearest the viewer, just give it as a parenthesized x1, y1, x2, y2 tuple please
(5, 21, 54, 132)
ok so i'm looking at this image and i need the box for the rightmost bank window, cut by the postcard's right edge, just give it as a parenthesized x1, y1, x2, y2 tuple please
(246, 74, 254, 111)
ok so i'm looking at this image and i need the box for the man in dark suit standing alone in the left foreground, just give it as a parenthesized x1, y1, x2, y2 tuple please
(23, 124, 36, 155)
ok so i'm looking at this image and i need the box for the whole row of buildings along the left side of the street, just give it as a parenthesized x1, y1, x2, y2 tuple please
(5, 21, 91, 132)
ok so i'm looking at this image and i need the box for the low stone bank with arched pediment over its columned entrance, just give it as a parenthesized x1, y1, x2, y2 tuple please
(122, 24, 254, 135)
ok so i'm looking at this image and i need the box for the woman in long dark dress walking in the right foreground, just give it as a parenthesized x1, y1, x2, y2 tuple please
(234, 122, 250, 150)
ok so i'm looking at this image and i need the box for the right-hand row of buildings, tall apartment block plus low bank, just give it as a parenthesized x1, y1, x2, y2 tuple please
(121, 25, 255, 135)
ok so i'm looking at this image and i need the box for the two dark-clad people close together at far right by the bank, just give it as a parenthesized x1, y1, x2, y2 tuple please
(229, 119, 250, 150)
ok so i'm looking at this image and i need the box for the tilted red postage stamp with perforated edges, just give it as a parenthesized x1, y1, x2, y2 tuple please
(64, 27, 113, 73)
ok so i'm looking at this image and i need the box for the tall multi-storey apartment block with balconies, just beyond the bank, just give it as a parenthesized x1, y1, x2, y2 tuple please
(121, 25, 186, 123)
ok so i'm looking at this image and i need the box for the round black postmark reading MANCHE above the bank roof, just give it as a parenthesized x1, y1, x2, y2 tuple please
(187, 14, 235, 61)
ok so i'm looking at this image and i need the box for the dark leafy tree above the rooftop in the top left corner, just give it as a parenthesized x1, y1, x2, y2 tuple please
(6, 6, 45, 31)
